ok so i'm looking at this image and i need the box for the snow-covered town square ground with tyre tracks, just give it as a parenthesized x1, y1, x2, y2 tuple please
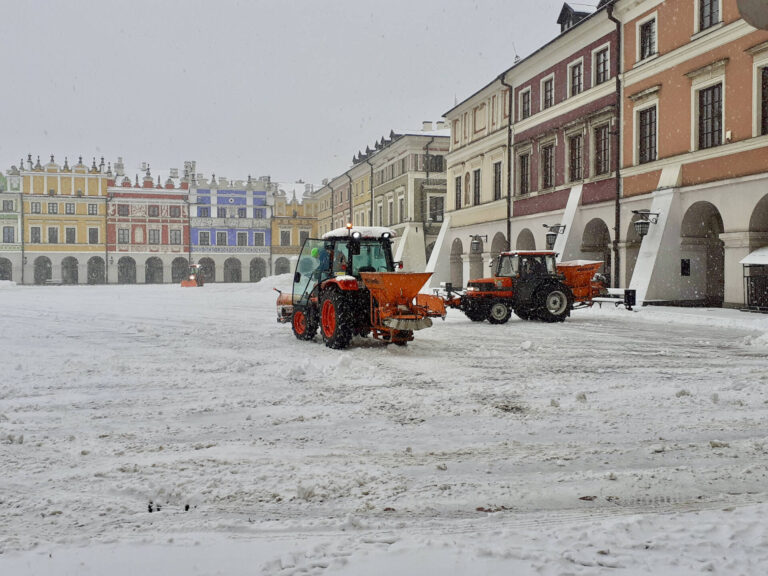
(0, 276, 768, 576)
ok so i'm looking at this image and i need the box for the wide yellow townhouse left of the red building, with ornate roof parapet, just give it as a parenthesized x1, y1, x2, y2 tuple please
(20, 155, 112, 284)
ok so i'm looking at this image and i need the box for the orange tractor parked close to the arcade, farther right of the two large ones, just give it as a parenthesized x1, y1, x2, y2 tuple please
(436, 251, 607, 324)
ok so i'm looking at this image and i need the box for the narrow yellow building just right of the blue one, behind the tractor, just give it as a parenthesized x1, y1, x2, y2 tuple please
(272, 185, 318, 274)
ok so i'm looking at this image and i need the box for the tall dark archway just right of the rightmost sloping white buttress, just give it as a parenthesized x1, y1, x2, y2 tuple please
(680, 202, 725, 306)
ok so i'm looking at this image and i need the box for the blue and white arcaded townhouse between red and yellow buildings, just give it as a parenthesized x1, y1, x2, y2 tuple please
(187, 170, 277, 282)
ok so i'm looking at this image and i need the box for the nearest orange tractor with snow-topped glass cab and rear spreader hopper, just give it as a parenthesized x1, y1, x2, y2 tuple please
(277, 226, 446, 349)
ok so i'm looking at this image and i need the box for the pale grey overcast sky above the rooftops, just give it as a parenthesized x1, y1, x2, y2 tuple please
(0, 0, 597, 190)
